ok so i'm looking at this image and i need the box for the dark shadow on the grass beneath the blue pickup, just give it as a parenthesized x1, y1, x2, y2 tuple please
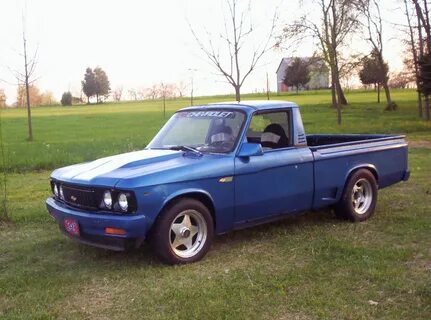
(23, 209, 345, 269)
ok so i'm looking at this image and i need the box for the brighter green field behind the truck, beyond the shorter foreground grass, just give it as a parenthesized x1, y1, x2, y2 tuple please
(2, 90, 431, 172)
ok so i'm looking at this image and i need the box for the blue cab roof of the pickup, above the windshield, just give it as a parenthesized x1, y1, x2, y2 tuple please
(182, 100, 298, 111)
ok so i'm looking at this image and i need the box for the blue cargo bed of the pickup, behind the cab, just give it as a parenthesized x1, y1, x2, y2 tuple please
(307, 134, 408, 208)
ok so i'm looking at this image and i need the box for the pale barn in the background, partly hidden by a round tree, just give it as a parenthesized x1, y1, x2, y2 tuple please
(277, 57, 330, 93)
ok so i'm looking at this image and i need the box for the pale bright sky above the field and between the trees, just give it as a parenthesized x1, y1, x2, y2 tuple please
(0, 0, 405, 104)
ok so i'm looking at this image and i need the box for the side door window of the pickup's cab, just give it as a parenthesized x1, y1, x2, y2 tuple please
(247, 111, 291, 151)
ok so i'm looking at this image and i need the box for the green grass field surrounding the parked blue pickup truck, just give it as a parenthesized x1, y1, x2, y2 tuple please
(0, 91, 431, 319)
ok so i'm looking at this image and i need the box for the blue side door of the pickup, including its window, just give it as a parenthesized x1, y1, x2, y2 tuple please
(234, 110, 314, 224)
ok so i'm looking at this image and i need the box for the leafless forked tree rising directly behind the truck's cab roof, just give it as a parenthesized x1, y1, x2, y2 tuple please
(190, 0, 277, 101)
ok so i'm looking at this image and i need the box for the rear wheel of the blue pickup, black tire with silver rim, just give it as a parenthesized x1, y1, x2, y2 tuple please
(335, 169, 377, 222)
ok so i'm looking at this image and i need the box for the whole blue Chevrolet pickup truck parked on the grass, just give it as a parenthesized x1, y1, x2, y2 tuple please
(46, 101, 409, 264)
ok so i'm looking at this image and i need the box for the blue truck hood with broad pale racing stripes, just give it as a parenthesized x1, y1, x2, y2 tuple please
(51, 149, 233, 188)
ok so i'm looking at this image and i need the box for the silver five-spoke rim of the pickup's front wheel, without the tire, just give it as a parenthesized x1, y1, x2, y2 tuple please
(169, 210, 208, 258)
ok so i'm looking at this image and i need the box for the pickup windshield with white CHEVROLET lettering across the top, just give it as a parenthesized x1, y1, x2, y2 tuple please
(148, 109, 245, 153)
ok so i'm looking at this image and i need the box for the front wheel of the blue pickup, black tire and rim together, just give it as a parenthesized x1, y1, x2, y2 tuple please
(150, 198, 214, 264)
